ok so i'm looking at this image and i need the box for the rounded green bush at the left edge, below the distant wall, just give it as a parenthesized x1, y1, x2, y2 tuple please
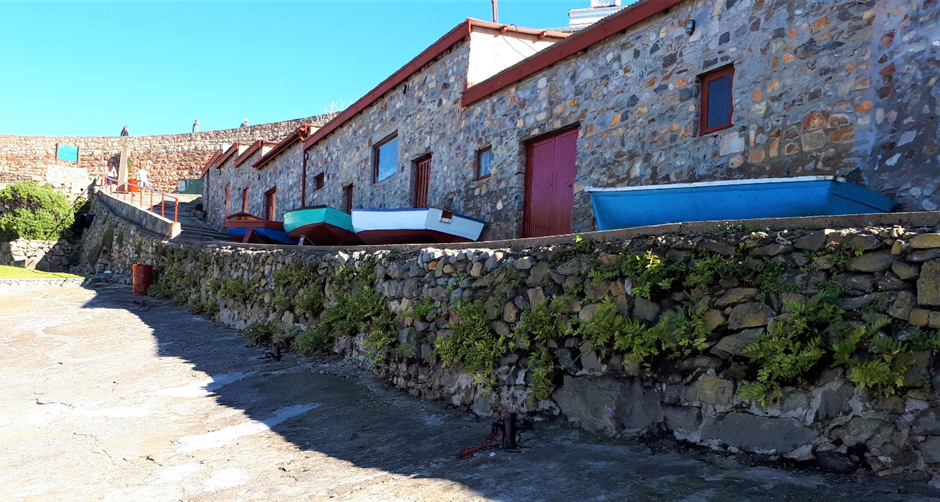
(0, 181, 75, 240)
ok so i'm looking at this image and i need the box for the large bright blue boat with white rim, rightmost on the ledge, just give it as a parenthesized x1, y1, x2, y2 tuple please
(584, 176, 897, 230)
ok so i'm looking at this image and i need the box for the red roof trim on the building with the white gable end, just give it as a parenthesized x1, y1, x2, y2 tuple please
(304, 18, 569, 150)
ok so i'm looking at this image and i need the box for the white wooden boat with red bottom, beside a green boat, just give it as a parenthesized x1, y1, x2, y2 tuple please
(352, 207, 486, 244)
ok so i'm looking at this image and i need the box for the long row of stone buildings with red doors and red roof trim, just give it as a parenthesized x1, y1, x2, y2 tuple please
(202, 0, 940, 239)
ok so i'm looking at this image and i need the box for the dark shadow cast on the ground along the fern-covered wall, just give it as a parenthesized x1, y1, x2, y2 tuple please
(77, 287, 940, 502)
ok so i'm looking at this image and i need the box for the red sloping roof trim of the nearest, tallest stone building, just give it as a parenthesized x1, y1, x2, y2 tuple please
(460, 0, 683, 106)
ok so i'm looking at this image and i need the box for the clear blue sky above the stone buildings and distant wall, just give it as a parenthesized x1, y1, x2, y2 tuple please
(0, 0, 590, 136)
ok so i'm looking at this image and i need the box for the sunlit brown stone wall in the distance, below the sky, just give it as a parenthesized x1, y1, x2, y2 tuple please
(0, 115, 327, 192)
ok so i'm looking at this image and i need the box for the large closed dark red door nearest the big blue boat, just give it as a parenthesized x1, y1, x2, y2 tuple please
(522, 129, 578, 237)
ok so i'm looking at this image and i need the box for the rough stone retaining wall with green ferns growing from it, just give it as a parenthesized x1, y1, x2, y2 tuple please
(85, 188, 940, 485)
